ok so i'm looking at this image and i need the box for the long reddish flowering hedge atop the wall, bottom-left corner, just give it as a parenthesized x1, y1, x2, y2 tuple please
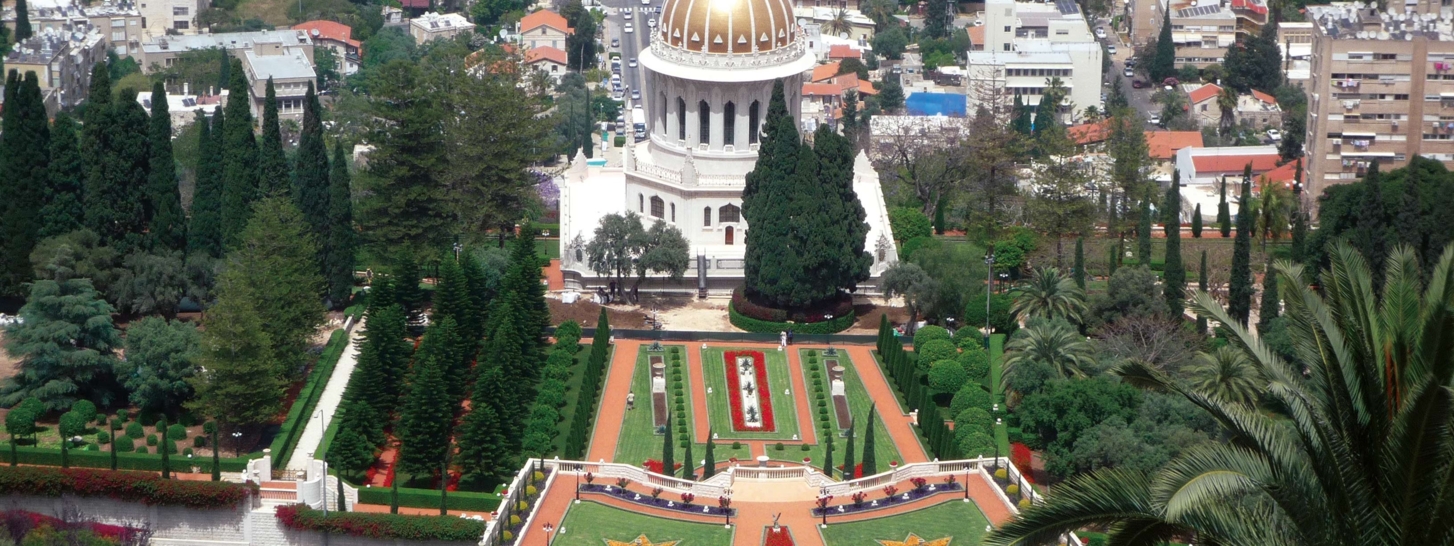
(0, 464, 254, 510)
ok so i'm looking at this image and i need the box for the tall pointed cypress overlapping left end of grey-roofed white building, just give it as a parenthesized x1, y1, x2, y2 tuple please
(214, 60, 257, 247)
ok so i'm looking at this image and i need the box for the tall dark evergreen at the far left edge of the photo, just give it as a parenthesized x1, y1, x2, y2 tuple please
(0, 71, 51, 295)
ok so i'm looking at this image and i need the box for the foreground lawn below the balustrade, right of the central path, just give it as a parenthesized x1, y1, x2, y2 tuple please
(820, 501, 989, 546)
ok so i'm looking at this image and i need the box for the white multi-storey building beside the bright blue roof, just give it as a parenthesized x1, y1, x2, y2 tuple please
(967, 0, 1104, 112)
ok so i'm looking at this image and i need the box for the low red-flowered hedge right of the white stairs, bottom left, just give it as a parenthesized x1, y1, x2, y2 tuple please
(276, 504, 484, 542)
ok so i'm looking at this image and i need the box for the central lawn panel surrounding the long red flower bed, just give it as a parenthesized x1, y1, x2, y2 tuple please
(702, 347, 807, 440)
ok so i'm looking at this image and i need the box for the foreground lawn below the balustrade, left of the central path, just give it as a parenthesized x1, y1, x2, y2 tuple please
(551, 501, 736, 546)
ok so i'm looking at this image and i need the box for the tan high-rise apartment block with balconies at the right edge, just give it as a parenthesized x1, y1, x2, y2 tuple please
(1306, 0, 1454, 203)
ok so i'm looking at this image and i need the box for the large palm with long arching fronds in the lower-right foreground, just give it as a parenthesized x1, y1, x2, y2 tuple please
(984, 241, 1454, 546)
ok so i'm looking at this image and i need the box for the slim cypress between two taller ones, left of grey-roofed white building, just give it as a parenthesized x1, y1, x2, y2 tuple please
(186, 106, 225, 258)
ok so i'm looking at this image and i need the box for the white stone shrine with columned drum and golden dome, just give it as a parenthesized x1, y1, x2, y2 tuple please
(560, 0, 897, 293)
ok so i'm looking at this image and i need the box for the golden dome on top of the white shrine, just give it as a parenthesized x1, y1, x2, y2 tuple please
(657, 0, 797, 54)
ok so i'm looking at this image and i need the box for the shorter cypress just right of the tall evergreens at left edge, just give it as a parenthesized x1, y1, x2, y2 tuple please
(38, 110, 86, 238)
